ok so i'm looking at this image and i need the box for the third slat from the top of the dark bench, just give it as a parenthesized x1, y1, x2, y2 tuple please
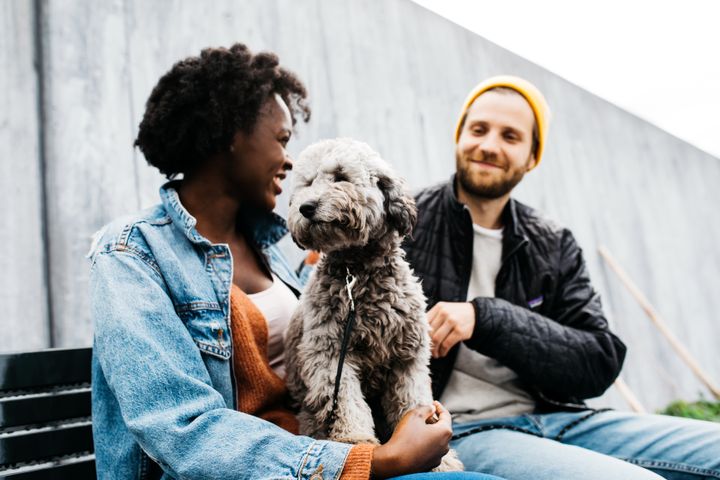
(0, 421, 93, 465)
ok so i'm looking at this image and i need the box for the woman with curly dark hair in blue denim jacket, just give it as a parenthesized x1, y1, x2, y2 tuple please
(91, 44, 500, 479)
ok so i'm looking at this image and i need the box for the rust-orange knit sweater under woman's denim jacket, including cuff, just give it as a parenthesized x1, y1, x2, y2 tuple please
(230, 285, 375, 480)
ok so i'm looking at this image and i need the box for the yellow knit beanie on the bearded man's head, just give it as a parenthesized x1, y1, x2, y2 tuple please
(455, 75, 550, 168)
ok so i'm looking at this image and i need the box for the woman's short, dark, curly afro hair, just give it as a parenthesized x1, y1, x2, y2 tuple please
(135, 43, 310, 178)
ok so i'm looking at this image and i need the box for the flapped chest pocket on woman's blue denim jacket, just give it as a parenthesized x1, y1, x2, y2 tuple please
(175, 302, 232, 360)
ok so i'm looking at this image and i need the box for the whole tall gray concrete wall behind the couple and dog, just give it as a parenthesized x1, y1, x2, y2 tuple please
(0, 0, 720, 409)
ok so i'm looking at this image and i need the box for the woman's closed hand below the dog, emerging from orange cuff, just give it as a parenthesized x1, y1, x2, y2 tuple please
(372, 402, 452, 478)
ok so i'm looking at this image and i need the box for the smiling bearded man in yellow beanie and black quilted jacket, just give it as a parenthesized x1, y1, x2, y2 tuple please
(406, 76, 720, 480)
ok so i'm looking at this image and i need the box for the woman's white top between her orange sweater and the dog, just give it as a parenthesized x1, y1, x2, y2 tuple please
(248, 273, 298, 378)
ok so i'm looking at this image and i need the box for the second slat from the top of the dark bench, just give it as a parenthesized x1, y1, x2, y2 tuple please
(0, 388, 90, 428)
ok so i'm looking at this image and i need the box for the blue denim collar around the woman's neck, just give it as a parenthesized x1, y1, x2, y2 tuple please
(160, 180, 288, 248)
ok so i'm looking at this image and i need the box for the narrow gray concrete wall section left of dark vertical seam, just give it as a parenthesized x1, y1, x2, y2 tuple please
(0, 0, 50, 349)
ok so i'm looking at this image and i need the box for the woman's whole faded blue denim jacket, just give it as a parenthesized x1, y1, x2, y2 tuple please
(89, 183, 350, 480)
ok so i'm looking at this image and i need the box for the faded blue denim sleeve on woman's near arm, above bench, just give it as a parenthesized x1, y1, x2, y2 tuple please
(90, 250, 350, 479)
